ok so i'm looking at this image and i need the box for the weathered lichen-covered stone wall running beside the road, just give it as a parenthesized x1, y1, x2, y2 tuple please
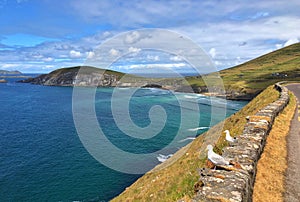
(193, 83, 289, 202)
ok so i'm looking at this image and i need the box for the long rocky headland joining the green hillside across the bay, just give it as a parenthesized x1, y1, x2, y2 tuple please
(21, 43, 300, 100)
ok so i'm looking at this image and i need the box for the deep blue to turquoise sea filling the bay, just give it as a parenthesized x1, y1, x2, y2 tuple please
(0, 75, 247, 201)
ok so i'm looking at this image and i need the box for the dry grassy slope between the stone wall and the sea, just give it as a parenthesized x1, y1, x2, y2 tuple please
(112, 87, 279, 201)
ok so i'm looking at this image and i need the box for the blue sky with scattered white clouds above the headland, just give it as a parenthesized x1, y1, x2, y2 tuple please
(0, 0, 300, 72)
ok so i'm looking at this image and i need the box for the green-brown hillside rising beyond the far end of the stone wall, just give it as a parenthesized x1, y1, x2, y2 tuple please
(188, 43, 300, 93)
